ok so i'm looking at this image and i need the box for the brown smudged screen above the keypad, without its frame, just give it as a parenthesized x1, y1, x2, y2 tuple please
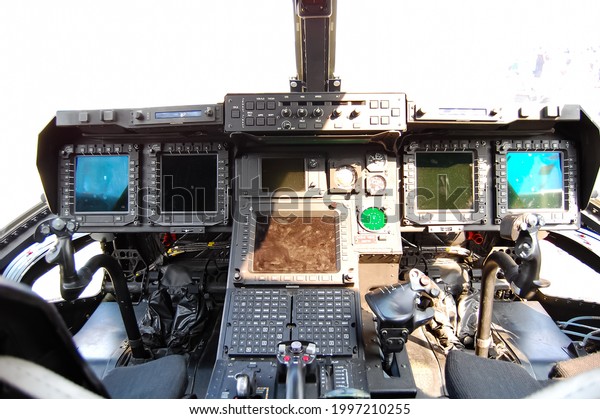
(252, 215, 338, 274)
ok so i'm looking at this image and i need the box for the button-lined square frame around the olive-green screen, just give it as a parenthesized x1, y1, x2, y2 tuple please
(403, 139, 490, 225)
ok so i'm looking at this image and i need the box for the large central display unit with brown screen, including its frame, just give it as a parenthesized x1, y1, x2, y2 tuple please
(232, 201, 357, 285)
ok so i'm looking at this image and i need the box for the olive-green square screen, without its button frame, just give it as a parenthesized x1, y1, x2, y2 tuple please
(416, 151, 474, 211)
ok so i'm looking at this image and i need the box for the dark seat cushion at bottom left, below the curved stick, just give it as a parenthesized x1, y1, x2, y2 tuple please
(102, 355, 187, 399)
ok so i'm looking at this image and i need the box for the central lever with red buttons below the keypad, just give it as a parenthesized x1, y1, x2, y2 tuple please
(277, 340, 317, 399)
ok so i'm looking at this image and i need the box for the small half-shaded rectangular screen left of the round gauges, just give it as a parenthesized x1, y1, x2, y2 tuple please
(261, 157, 306, 192)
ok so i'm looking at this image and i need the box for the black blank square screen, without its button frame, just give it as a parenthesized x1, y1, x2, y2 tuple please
(161, 154, 218, 213)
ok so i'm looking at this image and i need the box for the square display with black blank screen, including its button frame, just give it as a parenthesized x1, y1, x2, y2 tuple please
(145, 143, 229, 227)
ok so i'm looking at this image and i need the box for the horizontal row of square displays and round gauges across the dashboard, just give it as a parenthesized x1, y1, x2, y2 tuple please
(58, 136, 578, 233)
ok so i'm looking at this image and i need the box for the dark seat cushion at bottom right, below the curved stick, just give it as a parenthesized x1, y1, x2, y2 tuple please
(446, 351, 543, 399)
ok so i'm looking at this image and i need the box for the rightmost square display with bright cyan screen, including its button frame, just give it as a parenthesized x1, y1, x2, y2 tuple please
(495, 136, 578, 225)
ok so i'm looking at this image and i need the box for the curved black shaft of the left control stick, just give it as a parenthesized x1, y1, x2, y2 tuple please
(77, 255, 148, 358)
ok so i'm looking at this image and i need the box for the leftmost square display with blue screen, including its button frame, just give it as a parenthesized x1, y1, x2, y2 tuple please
(59, 144, 139, 228)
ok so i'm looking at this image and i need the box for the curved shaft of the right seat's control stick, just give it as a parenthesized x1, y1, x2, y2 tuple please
(475, 252, 519, 358)
